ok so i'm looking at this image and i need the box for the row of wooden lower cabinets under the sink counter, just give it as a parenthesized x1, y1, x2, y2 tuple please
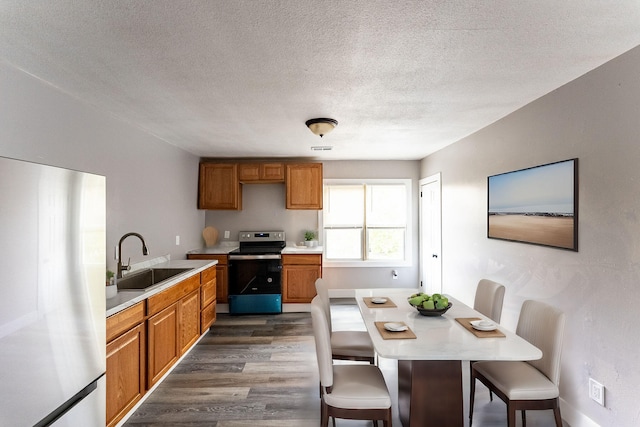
(106, 266, 217, 427)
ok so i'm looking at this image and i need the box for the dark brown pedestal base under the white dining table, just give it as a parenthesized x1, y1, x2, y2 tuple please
(398, 360, 464, 427)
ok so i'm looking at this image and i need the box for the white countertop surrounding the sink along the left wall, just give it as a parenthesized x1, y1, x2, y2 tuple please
(106, 259, 218, 317)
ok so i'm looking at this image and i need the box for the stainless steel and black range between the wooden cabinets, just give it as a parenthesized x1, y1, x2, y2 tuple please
(229, 231, 286, 314)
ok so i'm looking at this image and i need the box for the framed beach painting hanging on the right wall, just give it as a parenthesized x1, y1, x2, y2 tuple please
(487, 159, 578, 251)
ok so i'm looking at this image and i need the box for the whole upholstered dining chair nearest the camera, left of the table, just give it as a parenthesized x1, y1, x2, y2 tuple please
(311, 296, 392, 427)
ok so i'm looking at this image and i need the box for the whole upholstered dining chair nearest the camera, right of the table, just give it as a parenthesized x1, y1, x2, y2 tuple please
(469, 300, 565, 427)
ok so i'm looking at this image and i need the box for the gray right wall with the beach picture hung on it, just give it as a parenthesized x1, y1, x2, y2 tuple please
(420, 48, 640, 427)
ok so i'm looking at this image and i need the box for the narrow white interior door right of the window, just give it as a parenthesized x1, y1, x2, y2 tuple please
(419, 173, 442, 294)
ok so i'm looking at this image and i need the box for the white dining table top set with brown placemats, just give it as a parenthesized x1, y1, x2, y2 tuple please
(356, 288, 542, 360)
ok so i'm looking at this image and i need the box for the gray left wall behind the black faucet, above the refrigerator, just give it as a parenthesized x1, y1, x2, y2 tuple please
(0, 62, 204, 271)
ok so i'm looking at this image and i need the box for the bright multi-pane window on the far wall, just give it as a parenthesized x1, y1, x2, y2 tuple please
(322, 179, 411, 267)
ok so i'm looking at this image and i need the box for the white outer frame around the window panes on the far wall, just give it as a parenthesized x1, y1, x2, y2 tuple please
(318, 178, 413, 267)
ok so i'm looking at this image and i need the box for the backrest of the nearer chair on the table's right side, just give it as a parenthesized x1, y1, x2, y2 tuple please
(516, 300, 565, 385)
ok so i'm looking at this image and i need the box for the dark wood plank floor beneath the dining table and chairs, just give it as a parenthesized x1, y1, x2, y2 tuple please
(124, 304, 554, 427)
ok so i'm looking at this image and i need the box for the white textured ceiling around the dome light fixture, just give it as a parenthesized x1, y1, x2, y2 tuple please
(0, 0, 640, 159)
